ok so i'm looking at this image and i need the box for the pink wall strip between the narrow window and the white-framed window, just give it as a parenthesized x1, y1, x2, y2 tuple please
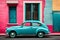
(17, 0, 23, 25)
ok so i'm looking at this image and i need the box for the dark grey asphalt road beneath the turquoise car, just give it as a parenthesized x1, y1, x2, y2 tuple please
(0, 36, 60, 40)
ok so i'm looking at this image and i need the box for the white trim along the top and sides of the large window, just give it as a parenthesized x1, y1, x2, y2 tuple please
(23, 1, 42, 22)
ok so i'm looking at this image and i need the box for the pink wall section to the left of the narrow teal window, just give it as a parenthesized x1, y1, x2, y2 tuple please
(0, 0, 8, 33)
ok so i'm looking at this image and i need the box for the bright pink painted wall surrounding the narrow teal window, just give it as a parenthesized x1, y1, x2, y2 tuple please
(0, 0, 45, 33)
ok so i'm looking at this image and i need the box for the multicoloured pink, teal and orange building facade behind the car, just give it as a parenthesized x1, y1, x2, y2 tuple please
(0, 0, 60, 33)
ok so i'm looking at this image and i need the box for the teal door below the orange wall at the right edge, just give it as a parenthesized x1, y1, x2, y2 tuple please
(53, 11, 60, 32)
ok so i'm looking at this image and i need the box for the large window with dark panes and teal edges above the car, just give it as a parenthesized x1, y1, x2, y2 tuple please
(25, 3, 39, 20)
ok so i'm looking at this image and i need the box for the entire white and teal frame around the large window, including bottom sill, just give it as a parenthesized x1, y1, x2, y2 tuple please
(23, 1, 42, 22)
